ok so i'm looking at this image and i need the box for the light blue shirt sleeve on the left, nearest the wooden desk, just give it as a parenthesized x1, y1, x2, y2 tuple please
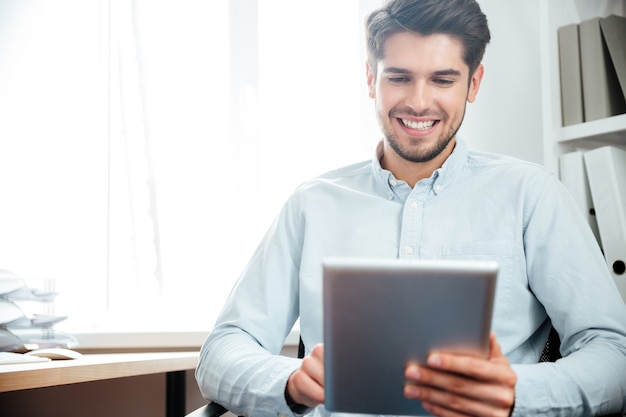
(196, 194, 302, 417)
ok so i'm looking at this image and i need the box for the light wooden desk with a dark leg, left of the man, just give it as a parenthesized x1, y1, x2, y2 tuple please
(0, 352, 198, 417)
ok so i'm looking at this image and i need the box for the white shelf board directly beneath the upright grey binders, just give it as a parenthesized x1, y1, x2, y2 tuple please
(556, 114, 626, 145)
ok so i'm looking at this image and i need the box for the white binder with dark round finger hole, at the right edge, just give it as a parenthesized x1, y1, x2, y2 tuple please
(584, 146, 626, 301)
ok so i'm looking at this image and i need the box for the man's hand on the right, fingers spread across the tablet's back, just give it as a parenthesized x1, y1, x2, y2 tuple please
(404, 332, 517, 417)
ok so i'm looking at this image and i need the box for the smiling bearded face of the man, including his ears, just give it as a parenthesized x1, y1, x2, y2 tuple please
(367, 32, 483, 162)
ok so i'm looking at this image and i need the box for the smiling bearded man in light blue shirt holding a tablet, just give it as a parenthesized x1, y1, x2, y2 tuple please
(196, 0, 626, 416)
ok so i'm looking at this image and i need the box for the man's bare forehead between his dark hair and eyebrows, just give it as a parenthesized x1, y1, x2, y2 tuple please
(377, 32, 469, 73)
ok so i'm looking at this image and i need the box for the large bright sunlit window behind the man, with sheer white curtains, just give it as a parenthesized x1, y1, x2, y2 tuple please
(0, 0, 379, 331)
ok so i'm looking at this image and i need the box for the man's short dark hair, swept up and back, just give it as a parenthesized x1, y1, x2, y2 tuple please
(366, 0, 491, 77)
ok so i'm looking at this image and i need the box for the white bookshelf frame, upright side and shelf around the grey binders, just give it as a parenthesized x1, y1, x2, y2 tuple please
(540, 0, 626, 172)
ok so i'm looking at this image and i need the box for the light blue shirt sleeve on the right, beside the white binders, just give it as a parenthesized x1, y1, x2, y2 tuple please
(513, 171, 626, 416)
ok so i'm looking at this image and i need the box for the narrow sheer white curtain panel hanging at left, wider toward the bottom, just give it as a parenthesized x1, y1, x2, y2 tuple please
(107, 0, 163, 309)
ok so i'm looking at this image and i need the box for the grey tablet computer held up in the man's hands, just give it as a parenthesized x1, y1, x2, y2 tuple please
(323, 258, 498, 415)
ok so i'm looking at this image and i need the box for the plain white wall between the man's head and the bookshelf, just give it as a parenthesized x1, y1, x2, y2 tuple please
(459, 0, 543, 163)
